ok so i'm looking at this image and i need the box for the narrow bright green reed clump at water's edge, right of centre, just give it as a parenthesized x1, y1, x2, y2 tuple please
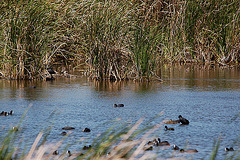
(131, 24, 159, 80)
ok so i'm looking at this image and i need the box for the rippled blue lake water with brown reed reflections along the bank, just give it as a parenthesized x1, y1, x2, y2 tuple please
(0, 66, 240, 159)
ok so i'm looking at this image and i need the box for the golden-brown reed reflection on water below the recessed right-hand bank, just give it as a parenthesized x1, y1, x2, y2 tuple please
(161, 65, 240, 90)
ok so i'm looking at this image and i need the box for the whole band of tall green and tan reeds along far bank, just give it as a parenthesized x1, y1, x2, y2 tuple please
(0, 0, 240, 80)
